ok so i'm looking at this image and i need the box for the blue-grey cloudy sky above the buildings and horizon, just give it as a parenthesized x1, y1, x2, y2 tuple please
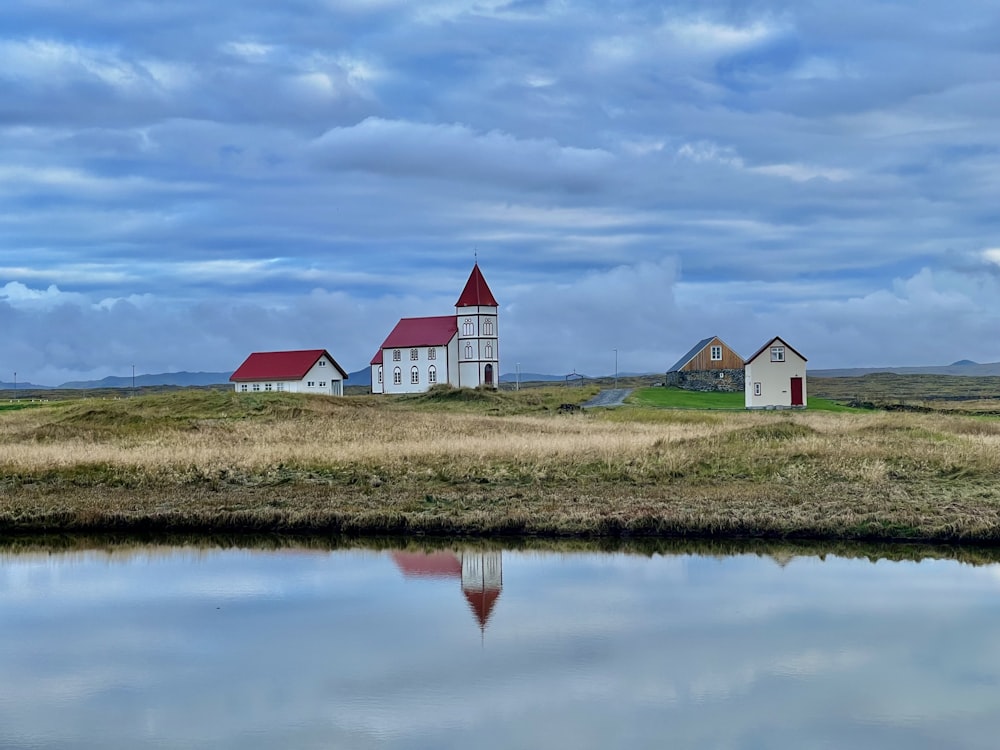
(0, 0, 1000, 385)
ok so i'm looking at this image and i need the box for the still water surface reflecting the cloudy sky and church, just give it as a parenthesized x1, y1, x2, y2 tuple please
(0, 547, 1000, 750)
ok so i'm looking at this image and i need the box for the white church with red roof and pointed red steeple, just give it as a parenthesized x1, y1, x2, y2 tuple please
(371, 262, 500, 393)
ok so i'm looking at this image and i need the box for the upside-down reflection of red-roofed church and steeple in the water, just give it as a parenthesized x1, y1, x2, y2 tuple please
(392, 550, 503, 631)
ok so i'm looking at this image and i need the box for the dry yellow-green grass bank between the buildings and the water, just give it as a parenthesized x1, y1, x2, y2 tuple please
(0, 387, 1000, 544)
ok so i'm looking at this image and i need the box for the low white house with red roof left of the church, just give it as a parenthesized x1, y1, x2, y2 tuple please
(229, 349, 347, 396)
